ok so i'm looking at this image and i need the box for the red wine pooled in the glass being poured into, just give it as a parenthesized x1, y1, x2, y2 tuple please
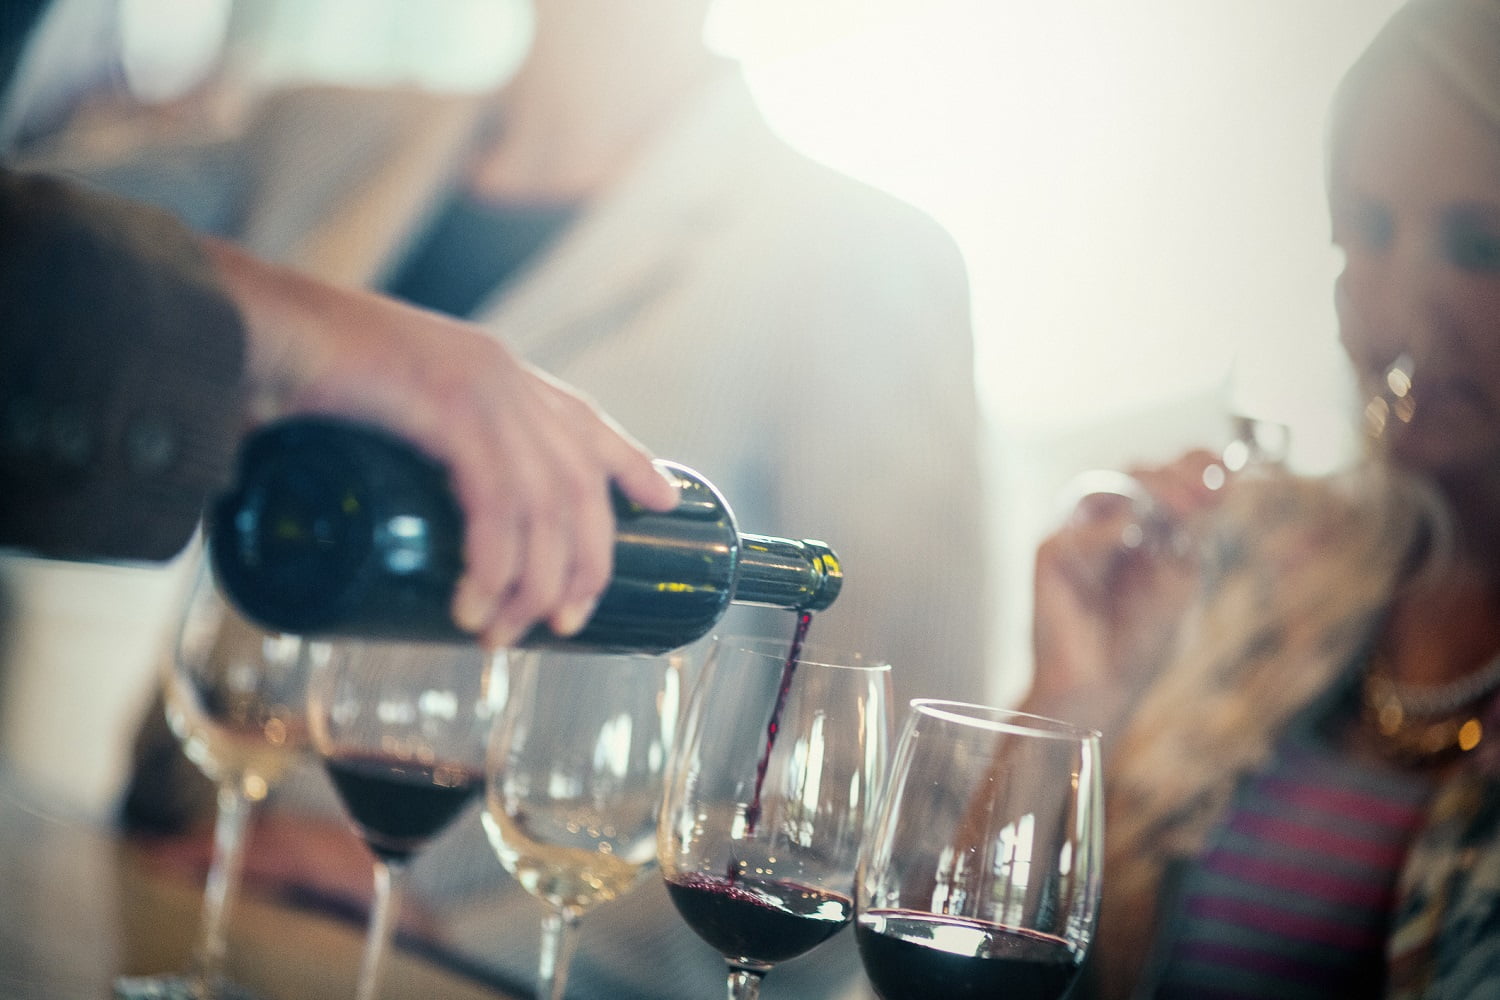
(666, 873, 854, 963)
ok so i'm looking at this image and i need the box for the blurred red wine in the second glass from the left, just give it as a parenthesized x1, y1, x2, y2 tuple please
(324, 754, 485, 861)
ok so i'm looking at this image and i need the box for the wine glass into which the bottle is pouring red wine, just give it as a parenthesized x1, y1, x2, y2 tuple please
(657, 639, 890, 1000)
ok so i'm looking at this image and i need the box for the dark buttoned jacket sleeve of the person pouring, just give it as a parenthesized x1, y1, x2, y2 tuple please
(0, 169, 245, 559)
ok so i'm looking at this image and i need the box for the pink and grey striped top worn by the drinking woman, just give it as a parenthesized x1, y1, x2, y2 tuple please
(1157, 736, 1431, 1000)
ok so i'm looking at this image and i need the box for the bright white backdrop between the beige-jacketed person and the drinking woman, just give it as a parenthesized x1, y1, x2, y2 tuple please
(737, 0, 1398, 700)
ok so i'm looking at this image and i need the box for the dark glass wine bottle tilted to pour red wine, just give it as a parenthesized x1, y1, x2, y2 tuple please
(209, 417, 843, 652)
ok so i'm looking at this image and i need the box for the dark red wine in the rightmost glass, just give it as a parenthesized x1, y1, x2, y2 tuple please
(855, 910, 1080, 1000)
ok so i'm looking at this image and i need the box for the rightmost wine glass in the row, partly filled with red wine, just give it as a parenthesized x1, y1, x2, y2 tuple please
(855, 699, 1104, 1000)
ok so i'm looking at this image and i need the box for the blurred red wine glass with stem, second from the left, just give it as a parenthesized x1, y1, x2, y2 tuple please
(308, 642, 498, 1000)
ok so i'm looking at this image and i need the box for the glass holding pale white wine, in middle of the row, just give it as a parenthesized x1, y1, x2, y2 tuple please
(480, 651, 681, 1000)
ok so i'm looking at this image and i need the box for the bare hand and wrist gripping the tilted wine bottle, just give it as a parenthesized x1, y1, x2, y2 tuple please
(267, 274, 677, 646)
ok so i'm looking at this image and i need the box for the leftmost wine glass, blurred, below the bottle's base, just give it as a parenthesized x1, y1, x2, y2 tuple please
(114, 547, 311, 1000)
